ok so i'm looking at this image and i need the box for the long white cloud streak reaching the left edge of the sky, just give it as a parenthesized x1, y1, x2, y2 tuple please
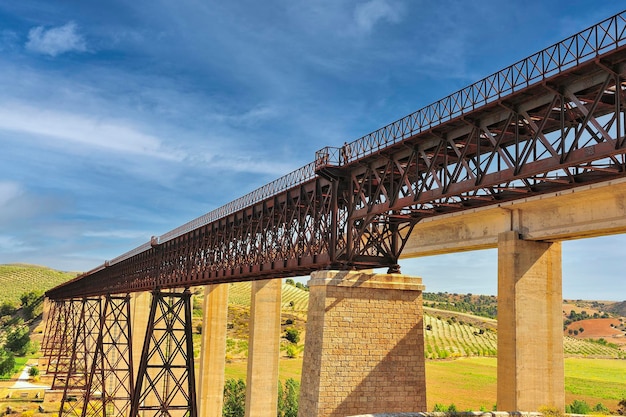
(0, 103, 184, 161)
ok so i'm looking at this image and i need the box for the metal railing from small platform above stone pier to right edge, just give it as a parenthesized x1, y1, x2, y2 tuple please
(316, 11, 626, 169)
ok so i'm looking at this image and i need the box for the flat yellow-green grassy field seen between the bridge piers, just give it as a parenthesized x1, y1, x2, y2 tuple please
(226, 357, 626, 411)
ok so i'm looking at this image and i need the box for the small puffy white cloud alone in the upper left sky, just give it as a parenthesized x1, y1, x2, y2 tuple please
(26, 22, 87, 57)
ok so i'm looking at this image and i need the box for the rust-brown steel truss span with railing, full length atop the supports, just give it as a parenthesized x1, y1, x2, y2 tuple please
(47, 12, 626, 299)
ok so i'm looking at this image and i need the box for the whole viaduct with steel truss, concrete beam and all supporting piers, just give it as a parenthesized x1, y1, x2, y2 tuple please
(42, 8, 626, 417)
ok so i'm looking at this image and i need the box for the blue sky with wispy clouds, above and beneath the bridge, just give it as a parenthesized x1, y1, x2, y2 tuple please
(0, 0, 626, 300)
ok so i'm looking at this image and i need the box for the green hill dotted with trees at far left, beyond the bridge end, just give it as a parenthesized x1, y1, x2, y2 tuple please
(0, 264, 78, 305)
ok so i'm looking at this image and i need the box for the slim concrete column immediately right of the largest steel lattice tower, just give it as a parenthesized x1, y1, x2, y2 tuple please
(196, 284, 229, 417)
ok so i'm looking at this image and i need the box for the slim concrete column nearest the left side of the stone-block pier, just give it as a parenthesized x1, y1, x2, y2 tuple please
(245, 279, 282, 417)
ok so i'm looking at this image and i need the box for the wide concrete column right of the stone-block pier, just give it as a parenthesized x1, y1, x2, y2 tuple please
(497, 232, 565, 411)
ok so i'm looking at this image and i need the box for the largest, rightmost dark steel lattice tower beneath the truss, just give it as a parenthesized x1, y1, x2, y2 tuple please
(130, 288, 198, 417)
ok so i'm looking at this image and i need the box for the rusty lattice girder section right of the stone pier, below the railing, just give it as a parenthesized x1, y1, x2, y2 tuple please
(334, 62, 626, 228)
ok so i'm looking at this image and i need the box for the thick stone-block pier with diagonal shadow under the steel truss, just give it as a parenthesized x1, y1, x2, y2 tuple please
(298, 271, 426, 417)
